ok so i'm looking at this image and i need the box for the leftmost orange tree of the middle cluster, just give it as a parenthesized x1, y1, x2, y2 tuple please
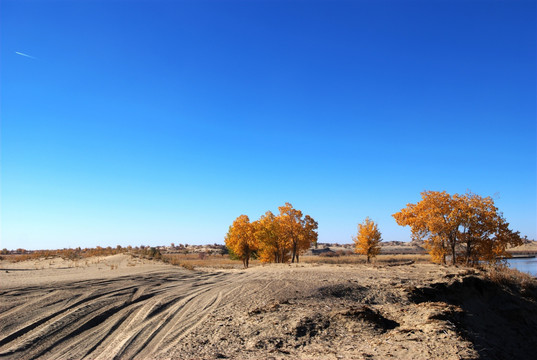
(225, 215, 257, 268)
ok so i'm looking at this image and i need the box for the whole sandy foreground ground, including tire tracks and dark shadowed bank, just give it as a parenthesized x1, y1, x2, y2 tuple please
(0, 255, 537, 359)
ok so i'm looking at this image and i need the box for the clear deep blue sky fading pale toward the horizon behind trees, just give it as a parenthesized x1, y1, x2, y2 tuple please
(0, 0, 537, 249)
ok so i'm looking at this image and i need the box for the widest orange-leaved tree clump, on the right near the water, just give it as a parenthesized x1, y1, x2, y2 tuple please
(392, 191, 521, 264)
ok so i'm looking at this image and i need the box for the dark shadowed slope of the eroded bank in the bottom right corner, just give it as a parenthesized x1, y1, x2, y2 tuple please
(410, 276, 537, 359)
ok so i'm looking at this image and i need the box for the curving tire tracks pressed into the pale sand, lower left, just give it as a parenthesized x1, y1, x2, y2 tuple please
(0, 268, 242, 359)
